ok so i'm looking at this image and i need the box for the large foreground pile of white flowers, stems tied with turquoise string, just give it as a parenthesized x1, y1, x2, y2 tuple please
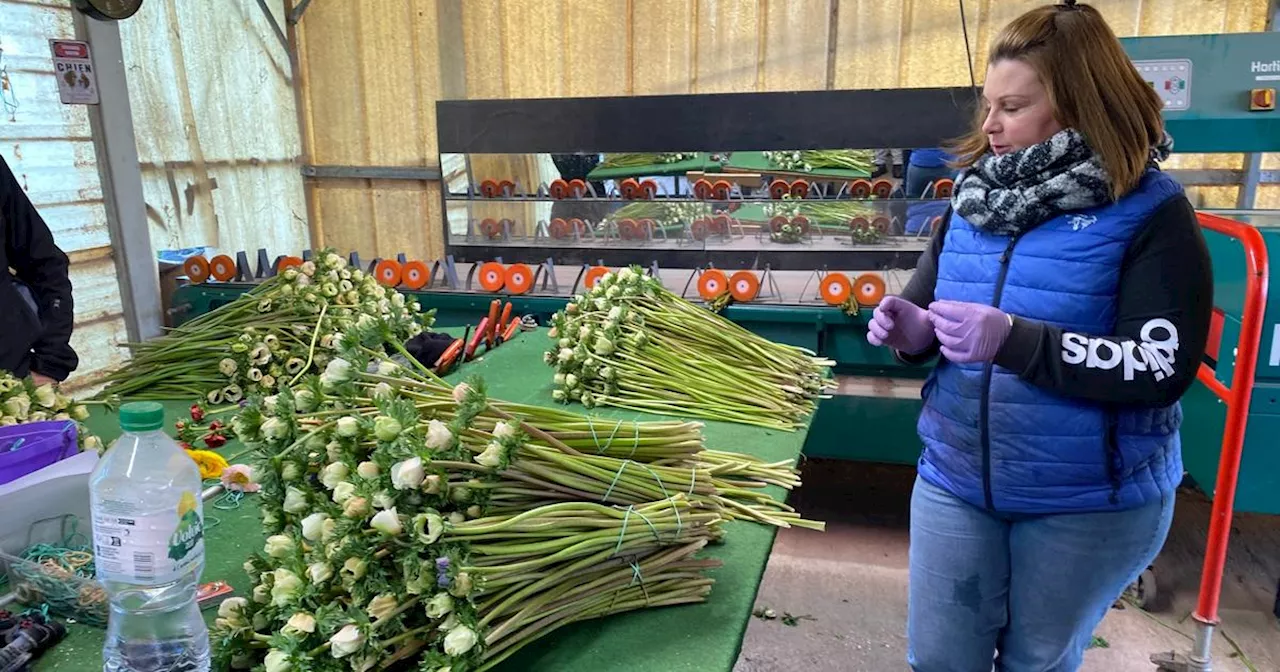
(214, 325, 822, 672)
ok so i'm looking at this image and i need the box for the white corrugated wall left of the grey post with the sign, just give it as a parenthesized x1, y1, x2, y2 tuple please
(0, 0, 128, 388)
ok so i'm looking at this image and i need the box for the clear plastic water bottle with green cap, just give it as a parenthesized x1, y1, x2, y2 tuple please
(90, 402, 209, 672)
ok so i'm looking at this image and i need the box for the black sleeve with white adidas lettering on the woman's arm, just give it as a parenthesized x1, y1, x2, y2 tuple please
(996, 197, 1213, 407)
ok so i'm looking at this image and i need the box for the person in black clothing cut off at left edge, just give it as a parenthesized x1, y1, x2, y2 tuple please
(0, 151, 79, 385)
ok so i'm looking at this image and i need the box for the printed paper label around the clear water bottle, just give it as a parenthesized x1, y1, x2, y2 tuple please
(93, 492, 205, 584)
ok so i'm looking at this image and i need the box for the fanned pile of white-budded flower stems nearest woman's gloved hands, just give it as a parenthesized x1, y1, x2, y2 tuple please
(544, 268, 833, 430)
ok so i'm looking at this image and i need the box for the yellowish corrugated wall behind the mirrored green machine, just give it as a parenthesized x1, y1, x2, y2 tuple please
(298, 0, 1280, 261)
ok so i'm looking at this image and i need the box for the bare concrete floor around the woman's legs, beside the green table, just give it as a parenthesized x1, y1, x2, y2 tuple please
(735, 460, 1280, 672)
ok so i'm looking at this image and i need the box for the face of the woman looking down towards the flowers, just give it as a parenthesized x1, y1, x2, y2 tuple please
(982, 59, 1062, 155)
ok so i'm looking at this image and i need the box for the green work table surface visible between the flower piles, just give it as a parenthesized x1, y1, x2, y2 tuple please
(47, 330, 805, 672)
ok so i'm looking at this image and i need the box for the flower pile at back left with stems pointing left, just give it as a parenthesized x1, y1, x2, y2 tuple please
(102, 250, 431, 404)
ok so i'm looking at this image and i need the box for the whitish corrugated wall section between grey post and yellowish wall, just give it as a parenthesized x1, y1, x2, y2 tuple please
(120, 0, 309, 259)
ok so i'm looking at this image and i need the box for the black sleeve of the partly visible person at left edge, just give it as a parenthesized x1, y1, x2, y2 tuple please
(0, 157, 79, 380)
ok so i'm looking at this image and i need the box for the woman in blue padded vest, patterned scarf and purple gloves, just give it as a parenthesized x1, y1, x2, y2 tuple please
(868, 3, 1213, 672)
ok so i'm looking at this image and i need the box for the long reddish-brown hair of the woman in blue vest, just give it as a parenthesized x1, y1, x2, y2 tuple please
(954, 1, 1165, 197)
